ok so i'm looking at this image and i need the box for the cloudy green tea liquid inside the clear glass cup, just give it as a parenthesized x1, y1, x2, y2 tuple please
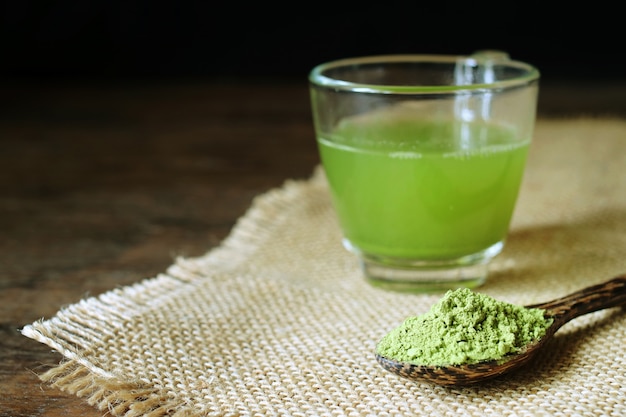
(318, 114, 530, 260)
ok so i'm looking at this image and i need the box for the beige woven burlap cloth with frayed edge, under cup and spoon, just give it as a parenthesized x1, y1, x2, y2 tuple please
(23, 118, 626, 416)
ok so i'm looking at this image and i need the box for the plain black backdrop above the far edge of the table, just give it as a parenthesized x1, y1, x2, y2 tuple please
(0, 0, 626, 82)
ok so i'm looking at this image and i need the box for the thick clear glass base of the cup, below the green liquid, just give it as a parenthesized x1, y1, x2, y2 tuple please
(344, 240, 504, 293)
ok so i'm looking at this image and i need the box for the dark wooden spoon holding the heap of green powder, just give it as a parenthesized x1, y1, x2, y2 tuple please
(376, 274, 626, 386)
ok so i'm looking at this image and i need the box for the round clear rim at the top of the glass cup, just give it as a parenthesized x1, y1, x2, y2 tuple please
(309, 53, 540, 94)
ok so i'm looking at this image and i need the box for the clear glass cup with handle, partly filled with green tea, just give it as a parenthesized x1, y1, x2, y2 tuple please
(309, 51, 539, 292)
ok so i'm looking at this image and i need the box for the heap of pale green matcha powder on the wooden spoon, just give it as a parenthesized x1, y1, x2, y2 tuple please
(377, 288, 552, 366)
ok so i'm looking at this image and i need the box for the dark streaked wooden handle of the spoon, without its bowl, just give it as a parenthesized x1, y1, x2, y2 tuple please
(529, 274, 626, 326)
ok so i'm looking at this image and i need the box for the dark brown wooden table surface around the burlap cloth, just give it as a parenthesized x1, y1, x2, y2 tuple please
(0, 79, 626, 417)
